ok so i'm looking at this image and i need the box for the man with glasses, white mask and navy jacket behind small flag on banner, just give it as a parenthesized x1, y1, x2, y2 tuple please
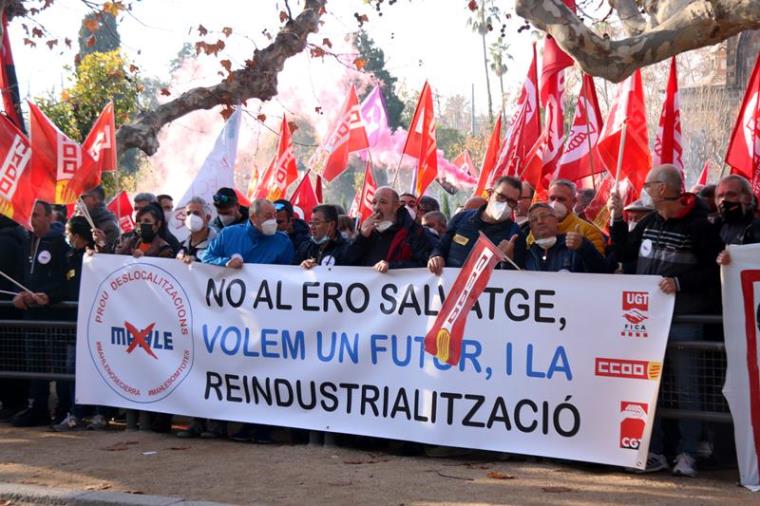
(428, 176, 525, 274)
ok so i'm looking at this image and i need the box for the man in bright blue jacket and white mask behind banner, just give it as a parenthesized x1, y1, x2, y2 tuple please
(200, 199, 295, 269)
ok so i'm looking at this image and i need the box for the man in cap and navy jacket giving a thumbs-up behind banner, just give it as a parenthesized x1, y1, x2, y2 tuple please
(525, 202, 606, 272)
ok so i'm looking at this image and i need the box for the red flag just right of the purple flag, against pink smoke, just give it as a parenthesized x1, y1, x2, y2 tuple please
(402, 81, 438, 197)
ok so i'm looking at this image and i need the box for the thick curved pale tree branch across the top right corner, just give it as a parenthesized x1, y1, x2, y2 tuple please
(515, 0, 760, 82)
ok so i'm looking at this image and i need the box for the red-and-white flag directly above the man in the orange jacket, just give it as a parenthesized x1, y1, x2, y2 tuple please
(557, 74, 605, 181)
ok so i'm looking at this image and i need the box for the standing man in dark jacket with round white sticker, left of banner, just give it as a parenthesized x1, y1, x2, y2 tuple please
(12, 201, 68, 427)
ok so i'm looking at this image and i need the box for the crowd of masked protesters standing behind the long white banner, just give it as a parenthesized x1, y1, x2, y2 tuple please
(0, 165, 760, 476)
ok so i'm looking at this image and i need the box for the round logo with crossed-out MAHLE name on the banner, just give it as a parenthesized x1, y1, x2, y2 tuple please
(87, 263, 194, 403)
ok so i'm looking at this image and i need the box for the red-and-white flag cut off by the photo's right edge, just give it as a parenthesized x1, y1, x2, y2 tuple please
(726, 54, 760, 197)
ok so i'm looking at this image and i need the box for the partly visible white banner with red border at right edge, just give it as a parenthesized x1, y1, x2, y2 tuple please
(721, 244, 760, 492)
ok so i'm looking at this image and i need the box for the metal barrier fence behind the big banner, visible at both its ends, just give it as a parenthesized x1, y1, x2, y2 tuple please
(0, 302, 731, 423)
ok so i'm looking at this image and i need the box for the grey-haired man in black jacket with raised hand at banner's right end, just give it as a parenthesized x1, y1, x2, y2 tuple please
(609, 165, 722, 476)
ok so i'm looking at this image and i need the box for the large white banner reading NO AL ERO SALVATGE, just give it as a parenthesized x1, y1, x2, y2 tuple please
(76, 255, 673, 468)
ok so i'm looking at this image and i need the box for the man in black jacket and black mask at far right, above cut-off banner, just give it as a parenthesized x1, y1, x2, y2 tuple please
(715, 174, 760, 265)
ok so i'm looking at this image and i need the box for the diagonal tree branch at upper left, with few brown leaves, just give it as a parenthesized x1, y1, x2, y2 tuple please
(116, 0, 326, 155)
